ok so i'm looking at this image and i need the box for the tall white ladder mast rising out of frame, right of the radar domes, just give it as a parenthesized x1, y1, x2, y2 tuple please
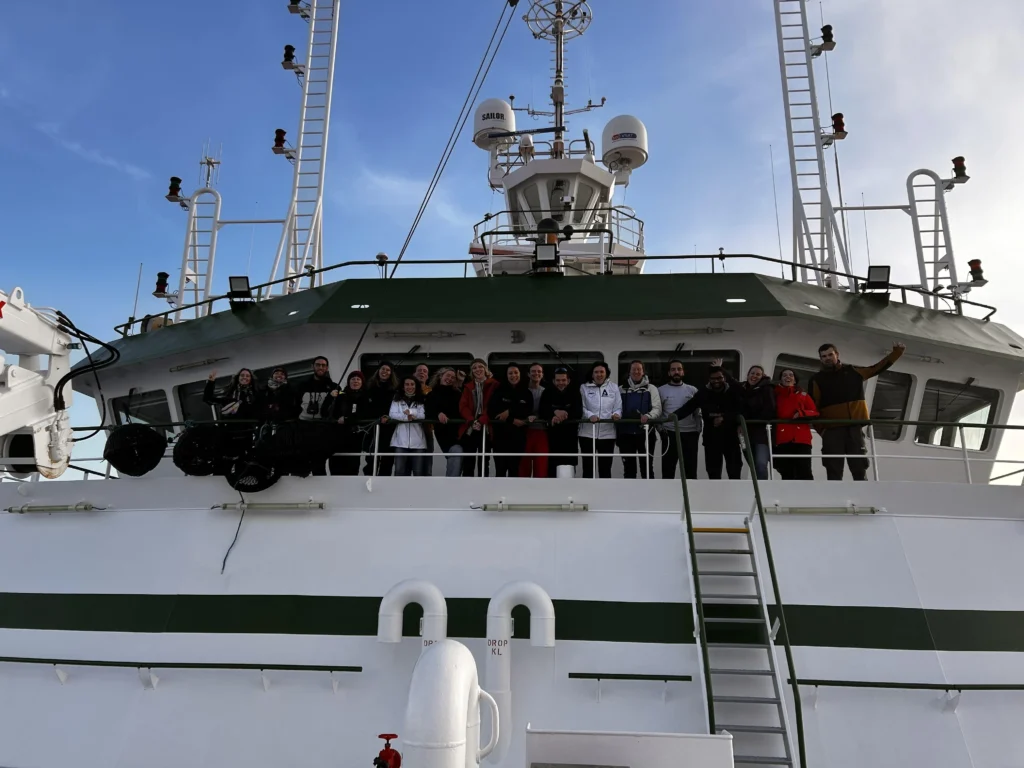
(774, 0, 850, 288)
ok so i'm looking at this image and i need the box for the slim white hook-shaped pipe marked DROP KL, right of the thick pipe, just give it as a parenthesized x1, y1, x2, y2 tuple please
(485, 582, 555, 763)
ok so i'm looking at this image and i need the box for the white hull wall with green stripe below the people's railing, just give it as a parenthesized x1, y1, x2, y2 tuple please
(0, 477, 1024, 768)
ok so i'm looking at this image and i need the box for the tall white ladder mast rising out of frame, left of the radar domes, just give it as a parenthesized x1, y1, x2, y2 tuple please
(270, 0, 340, 293)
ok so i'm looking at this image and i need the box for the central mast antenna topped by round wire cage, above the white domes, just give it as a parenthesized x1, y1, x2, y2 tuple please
(520, 0, 605, 158)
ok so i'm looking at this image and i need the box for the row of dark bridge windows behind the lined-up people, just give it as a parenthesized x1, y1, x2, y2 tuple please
(111, 347, 998, 451)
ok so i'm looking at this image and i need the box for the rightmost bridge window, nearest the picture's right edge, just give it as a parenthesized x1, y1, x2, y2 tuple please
(915, 379, 999, 451)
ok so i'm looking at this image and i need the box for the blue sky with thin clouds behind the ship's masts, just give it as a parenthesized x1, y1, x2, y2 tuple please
(0, 0, 1024, 468)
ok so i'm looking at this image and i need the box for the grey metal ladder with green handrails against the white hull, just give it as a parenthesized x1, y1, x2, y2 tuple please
(693, 518, 797, 766)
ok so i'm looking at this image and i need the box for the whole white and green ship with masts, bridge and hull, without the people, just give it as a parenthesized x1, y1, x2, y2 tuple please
(0, 0, 1024, 768)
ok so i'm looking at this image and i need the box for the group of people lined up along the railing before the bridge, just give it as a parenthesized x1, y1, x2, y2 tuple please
(204, 343, 905, 480)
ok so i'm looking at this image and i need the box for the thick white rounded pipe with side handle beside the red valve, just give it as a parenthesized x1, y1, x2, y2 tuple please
(402, 640, 502, 768)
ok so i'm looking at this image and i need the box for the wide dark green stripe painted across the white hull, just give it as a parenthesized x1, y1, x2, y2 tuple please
(0, 593, 1024, 652)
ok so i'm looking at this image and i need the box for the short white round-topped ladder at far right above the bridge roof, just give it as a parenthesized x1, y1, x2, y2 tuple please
(906, 169, 957, 309)
